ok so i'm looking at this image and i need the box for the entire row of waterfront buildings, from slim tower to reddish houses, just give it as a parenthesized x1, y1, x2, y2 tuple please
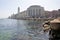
(9, 5, 60, 19)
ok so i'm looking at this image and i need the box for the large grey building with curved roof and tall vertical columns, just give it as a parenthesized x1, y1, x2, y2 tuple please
(27, 5, 44, 18)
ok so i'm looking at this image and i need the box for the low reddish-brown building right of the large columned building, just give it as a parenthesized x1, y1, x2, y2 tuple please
(45, 9, 60, 18)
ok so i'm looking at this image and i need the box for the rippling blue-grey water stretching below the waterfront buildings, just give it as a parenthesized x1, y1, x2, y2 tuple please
(0, 19, 48, 40)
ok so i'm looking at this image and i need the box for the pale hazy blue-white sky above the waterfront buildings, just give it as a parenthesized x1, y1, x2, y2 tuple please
(0, 0, 60, 18)
